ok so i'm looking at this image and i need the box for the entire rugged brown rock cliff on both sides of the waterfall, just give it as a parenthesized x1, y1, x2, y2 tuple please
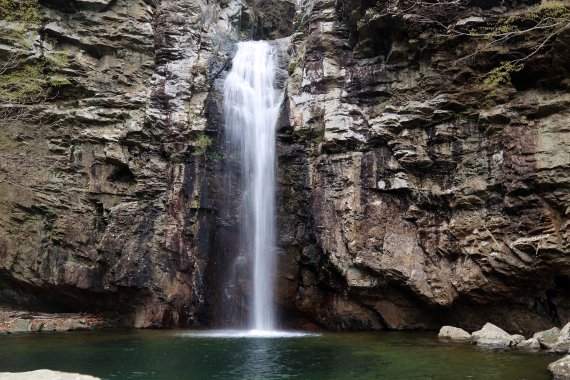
(0, 0, 570, 331)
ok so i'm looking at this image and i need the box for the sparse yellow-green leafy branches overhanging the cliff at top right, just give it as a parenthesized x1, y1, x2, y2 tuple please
(377, 0, 570, 94)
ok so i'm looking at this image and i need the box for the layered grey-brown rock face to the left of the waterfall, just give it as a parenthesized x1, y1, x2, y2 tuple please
(0, 0, 294, 327)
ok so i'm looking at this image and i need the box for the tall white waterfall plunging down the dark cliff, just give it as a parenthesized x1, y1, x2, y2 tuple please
(224, 41, 279, 331)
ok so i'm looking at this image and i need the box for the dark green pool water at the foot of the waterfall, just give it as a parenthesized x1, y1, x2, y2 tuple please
(0, 330, 559, 380)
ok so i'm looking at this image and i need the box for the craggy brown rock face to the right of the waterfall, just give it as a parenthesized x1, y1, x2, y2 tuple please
(281, 0, 570, 330)
